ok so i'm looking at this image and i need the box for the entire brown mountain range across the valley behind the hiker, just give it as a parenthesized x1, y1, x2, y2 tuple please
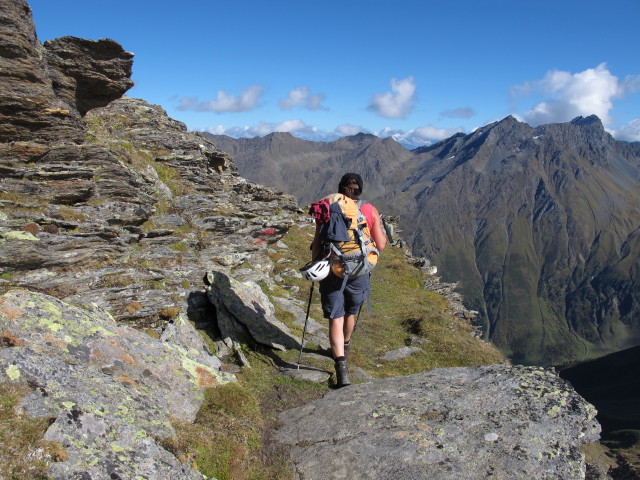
(205, 116, 640, 365)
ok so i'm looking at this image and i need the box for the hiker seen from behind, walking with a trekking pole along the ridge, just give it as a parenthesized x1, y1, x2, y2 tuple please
(311, 173, 387, 387)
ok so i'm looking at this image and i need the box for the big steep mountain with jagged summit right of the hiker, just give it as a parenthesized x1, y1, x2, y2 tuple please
(402, 117, 640, 364)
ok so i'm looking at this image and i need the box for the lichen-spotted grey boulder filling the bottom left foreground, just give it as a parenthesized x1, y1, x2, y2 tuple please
(0, 290, 235, 480)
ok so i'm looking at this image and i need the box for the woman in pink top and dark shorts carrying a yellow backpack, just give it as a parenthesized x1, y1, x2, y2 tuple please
(310, 173, 387, 388)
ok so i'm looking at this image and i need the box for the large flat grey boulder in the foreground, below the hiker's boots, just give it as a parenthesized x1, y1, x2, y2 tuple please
(275, 365, 600, 480)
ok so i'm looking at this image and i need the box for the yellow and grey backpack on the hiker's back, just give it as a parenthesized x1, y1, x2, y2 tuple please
(309, 193, 380, 281)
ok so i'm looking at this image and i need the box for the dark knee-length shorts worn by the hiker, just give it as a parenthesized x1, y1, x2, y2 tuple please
(320, 274, 369, 318)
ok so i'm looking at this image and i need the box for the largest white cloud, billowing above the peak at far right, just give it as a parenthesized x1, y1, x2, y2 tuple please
(511, 63, 640, 125)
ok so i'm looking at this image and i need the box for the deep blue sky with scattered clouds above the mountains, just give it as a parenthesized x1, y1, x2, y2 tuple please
(27, 0, 640, 147)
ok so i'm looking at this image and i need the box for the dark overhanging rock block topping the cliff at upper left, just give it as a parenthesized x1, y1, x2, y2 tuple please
(0, 0, 133, 142)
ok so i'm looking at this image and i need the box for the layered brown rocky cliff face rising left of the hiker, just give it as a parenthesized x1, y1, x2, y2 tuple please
(0, 0, 298, 327)
